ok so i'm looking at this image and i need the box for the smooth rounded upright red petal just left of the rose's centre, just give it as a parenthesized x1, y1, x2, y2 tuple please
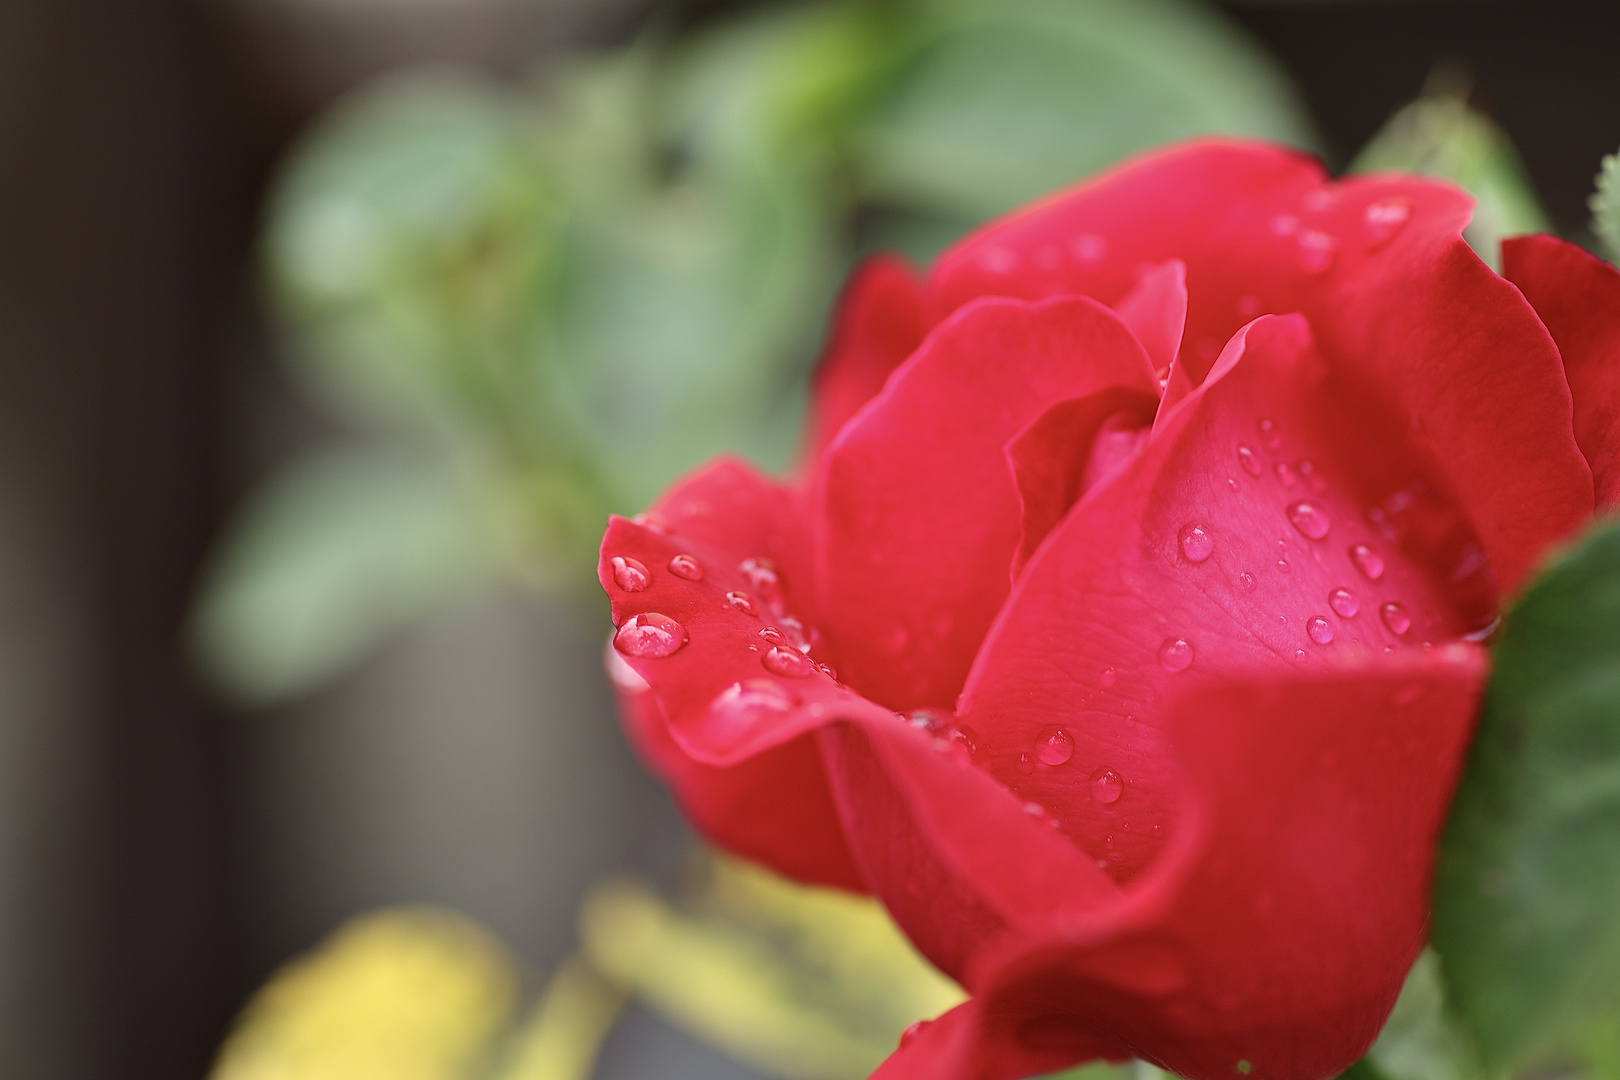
(815, 296, 1153, 718)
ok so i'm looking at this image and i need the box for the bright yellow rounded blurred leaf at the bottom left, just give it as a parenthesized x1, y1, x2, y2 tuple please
(212, 908, 518, 1080)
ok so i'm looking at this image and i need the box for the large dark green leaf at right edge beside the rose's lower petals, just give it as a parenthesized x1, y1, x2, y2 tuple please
(1434, 521, 1620, 1077)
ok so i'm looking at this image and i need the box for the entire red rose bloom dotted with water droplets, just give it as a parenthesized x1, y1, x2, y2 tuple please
(599, 141, 1620, 1080)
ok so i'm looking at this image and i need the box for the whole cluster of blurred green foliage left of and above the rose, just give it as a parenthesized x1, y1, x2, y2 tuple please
(196, 0, 1312, 703)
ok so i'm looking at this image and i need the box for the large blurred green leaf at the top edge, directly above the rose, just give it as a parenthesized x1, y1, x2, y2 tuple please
(859, 0, 1314, 223)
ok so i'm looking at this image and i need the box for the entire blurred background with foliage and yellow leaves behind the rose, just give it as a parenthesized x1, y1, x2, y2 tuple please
(0, 0, 1620, 1080)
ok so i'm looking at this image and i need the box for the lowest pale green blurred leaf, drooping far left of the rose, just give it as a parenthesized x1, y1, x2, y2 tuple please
(191, 450, 491, 703)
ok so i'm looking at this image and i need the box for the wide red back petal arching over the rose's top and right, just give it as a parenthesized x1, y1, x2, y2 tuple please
(932, 141, 1591, 589)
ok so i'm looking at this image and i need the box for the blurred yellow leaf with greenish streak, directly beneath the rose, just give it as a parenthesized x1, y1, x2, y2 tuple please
(580, 857, 964, 1080)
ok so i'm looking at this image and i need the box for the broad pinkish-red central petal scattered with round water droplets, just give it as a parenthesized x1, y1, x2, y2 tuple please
(952, 316, 1495, 889)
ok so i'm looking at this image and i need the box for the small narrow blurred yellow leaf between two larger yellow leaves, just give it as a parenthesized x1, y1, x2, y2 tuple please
(494, 957, 624, 1080)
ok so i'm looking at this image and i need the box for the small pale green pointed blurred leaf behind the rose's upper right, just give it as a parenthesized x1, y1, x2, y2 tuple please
(1349, 68, 1552, 269)
